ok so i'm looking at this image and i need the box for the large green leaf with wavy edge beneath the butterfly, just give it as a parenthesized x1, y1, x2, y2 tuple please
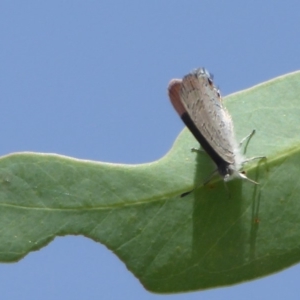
(0, 72, 300, 293)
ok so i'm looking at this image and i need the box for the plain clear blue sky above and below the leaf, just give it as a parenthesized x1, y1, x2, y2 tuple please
(0, 0, 300, 300)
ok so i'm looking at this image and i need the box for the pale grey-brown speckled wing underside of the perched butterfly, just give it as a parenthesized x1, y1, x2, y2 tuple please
(180, 69, 236, 163)
